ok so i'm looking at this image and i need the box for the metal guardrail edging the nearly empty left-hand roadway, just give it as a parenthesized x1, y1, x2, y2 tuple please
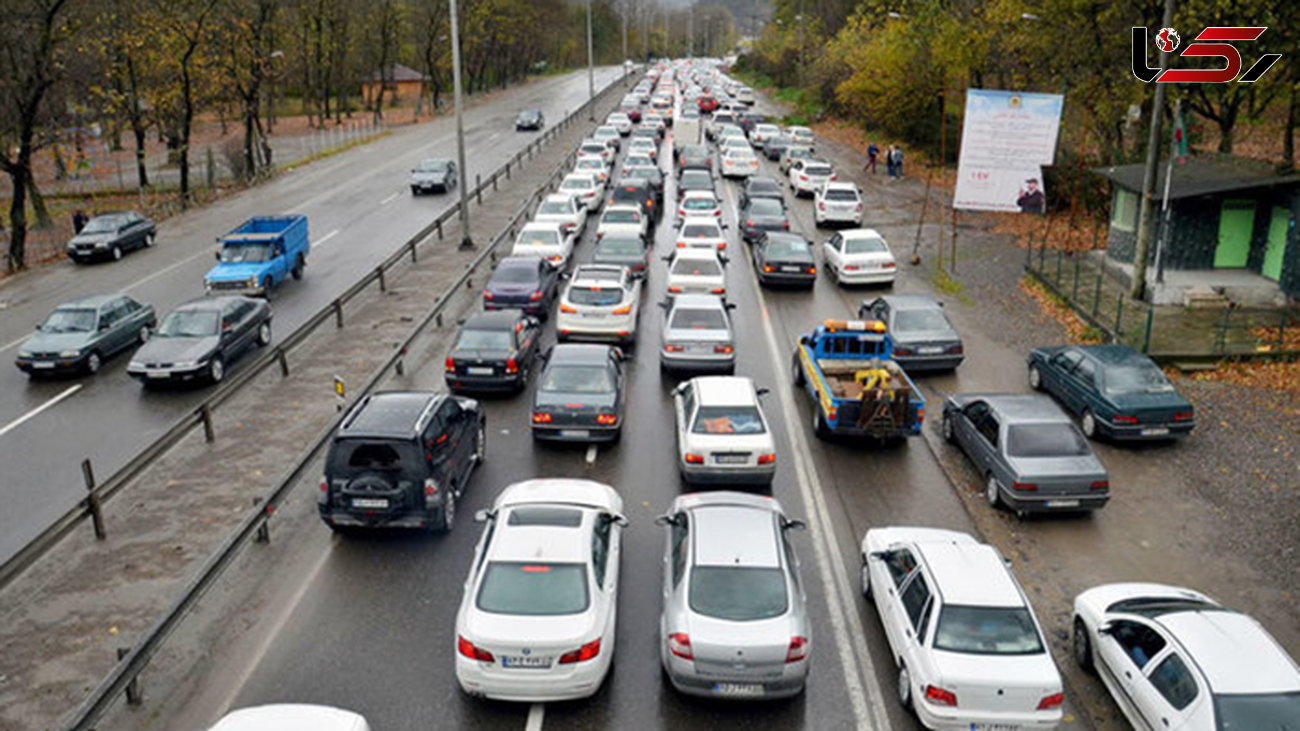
(0, 71, 625, 588)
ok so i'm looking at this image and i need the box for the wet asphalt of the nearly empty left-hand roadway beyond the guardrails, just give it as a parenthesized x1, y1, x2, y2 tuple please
(0, 68, 621, 561)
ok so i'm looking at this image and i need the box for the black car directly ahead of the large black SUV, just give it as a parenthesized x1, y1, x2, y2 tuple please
(443, 310, 542, 393)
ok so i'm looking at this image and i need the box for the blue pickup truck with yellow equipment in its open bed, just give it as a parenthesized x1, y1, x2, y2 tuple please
(792, 320, 926, 442)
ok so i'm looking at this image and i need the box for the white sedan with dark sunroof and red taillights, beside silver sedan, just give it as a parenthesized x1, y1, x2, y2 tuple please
(456, 479, 628, 702)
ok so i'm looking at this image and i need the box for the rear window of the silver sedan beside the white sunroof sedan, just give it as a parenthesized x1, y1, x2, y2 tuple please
(689, 566, 789, 616)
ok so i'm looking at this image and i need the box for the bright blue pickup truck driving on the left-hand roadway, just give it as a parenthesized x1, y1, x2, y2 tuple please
(203, 215, 312, 298)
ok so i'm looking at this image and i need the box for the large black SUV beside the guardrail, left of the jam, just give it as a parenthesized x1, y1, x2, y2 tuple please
(316, 392, 488, 532)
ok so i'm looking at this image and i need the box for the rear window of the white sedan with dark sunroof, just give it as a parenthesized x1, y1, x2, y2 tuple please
(477, 561, 589, 617)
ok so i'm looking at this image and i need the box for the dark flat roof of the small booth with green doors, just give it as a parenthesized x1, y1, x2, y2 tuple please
(1092, 155, 1300, 199)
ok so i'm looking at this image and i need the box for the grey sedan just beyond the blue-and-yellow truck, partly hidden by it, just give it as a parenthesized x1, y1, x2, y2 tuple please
(858, 294, 966, 373)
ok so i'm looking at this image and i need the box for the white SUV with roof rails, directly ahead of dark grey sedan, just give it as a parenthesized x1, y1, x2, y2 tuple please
(555, 264, 641, 345)
